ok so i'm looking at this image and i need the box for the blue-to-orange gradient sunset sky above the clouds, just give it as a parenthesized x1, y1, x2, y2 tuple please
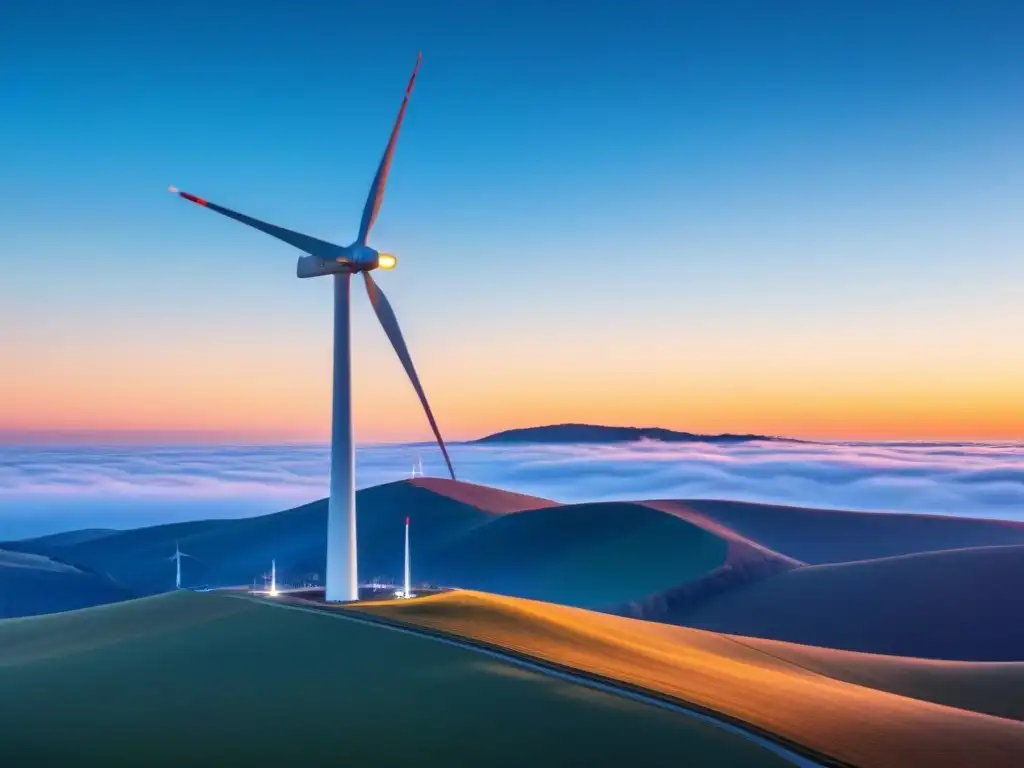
(0, 0, 1024, 440)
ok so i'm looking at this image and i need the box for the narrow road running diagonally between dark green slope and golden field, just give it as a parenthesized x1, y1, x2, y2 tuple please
(239, 595, 825, 768)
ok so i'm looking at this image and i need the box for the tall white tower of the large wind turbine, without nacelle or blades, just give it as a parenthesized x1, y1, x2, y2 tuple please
(325, 273, 359, 602)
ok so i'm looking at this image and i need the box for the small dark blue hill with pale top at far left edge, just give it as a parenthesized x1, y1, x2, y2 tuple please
(0, 550, 133, 618)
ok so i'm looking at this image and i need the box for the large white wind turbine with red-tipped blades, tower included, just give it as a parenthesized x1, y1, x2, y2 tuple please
(170, 54, 455, 601)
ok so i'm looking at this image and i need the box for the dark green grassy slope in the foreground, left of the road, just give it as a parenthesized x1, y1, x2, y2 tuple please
(0, 593, 785, 768)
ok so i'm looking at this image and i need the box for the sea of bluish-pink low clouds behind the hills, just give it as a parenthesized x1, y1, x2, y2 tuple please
(0, 441, 1024, 541)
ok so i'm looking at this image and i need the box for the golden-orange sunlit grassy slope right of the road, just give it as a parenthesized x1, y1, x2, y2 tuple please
(354, 592, 1024, 768)
